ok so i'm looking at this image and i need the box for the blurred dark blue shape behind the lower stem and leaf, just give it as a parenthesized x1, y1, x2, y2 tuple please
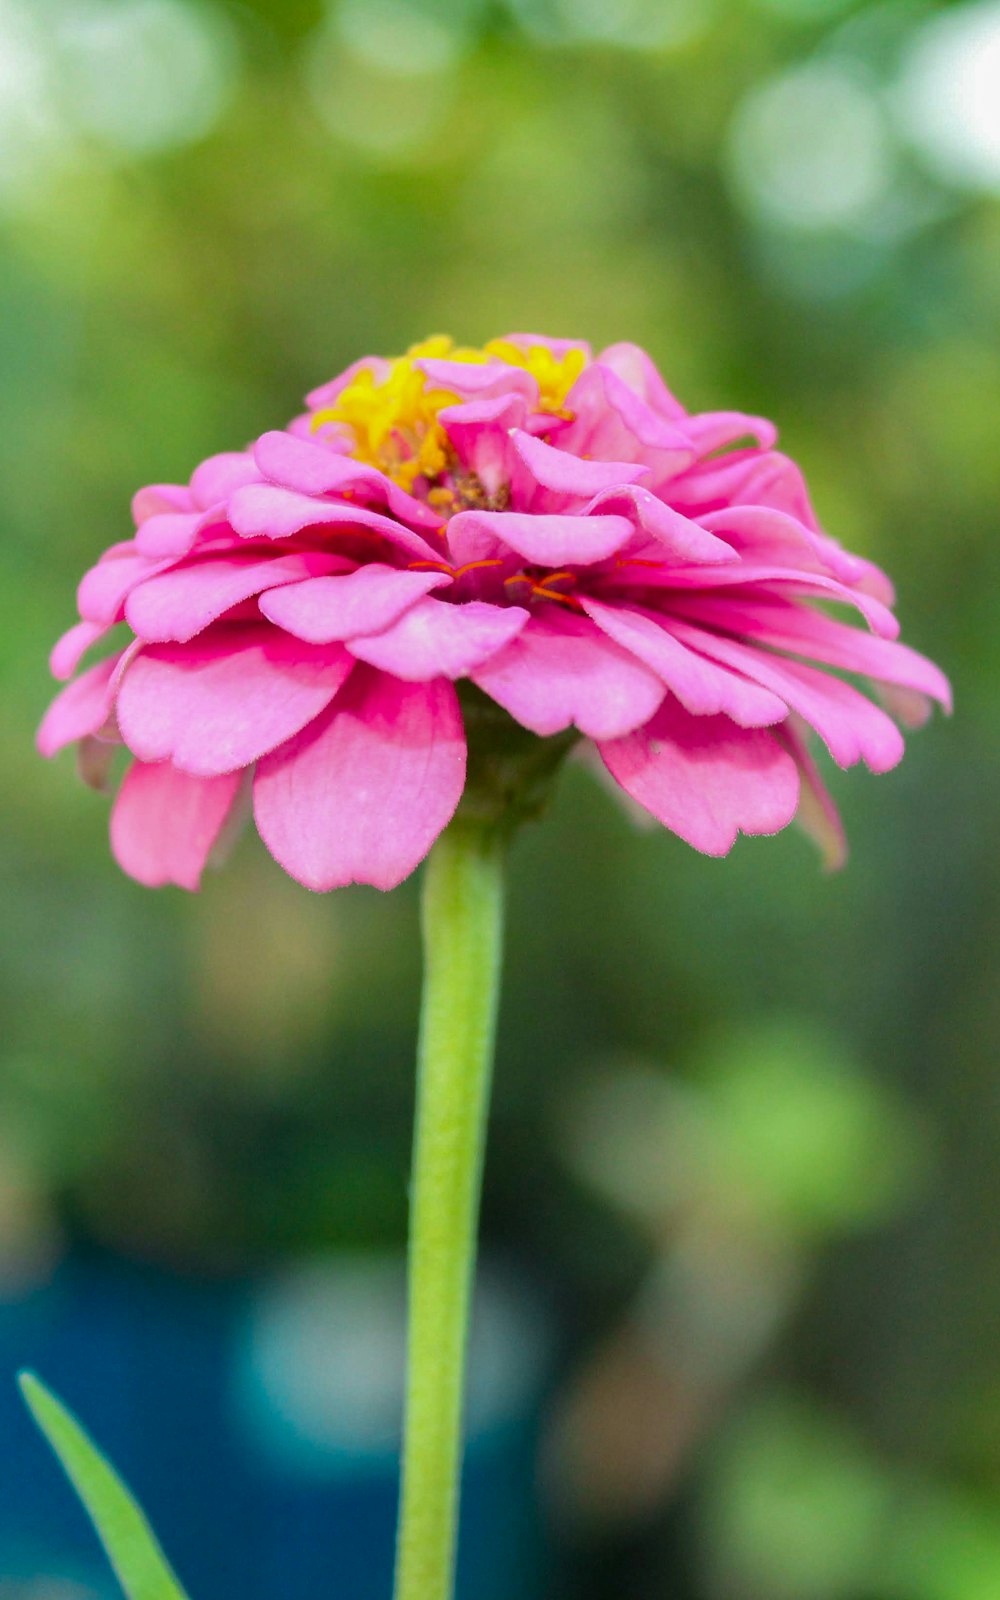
(0, 1256, 549, 1600)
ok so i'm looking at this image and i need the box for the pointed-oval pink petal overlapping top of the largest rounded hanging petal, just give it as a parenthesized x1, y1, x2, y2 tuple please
(347, 598, 528, 683)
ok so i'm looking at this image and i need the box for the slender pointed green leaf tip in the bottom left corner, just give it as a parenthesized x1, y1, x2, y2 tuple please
(18, 1373, 187, 1600)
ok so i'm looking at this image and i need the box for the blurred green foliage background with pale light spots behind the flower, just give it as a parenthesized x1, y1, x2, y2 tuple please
(0, 0, 1000, 1600)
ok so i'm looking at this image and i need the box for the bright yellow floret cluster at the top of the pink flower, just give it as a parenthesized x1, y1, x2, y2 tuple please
(312, 334, 586, 490)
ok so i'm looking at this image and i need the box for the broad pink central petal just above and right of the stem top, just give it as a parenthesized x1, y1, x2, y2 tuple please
(470, 605, 664, 739)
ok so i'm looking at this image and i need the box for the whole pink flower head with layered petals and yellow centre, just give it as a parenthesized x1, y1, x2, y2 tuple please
(38, 336, 949, 890)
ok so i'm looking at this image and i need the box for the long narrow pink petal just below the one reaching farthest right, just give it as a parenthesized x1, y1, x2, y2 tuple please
(667, 618, 902, 773)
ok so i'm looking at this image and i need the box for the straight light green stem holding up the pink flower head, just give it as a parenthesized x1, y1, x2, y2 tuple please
(395, 818, 502, 1600)
